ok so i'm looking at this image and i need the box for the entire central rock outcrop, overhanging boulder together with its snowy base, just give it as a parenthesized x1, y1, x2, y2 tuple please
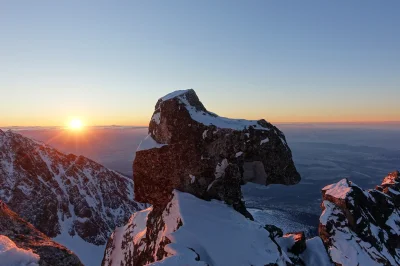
(103, 90, 300, 265)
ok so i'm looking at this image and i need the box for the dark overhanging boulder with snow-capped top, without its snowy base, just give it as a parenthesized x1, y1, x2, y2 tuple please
(133, 90, 300, 217)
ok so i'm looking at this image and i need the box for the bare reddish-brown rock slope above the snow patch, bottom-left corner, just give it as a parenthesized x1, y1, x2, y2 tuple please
(0, 201, 83, 266)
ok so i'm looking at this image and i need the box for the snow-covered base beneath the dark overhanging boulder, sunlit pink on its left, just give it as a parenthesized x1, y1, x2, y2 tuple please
(103, 190, 291, 266)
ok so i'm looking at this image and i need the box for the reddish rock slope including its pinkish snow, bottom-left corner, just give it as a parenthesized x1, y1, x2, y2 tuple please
(0, 201, 83, 266)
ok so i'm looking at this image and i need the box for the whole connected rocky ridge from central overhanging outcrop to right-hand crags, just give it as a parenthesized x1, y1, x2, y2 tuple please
(102, 90, 400, 266)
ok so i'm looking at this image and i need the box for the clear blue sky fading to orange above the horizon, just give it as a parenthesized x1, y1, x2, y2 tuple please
(0, 0, 400, 127)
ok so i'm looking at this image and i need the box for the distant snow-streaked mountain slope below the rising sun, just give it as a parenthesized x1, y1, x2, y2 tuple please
(0, 131, 143, 245)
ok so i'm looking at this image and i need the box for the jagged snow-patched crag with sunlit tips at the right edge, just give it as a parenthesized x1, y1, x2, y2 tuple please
(319, 171, 400, 266)
